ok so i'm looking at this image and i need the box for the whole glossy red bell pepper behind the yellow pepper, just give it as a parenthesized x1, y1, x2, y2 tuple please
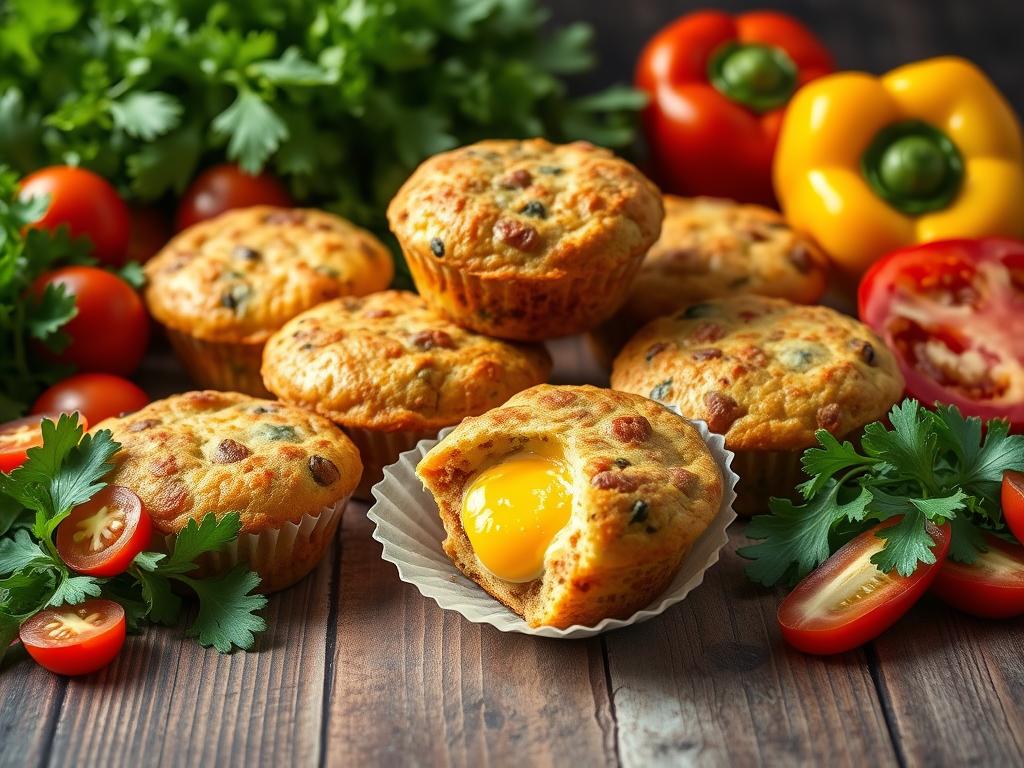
(636, 11, 835, 205)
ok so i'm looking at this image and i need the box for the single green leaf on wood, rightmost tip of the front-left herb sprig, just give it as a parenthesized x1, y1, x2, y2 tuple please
(179, 563, 266, 653)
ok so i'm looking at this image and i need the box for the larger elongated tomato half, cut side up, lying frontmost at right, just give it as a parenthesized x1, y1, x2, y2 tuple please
(778, 518, 949, 653)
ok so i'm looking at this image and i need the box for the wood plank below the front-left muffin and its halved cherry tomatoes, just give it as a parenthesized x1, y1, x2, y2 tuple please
(38, 548, 337, 766)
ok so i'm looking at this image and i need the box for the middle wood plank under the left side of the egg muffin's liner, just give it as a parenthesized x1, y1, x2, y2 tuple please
(325, 501, 615, 766)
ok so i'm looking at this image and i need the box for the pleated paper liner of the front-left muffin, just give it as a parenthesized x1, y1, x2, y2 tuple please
(163, 496, 351, 592)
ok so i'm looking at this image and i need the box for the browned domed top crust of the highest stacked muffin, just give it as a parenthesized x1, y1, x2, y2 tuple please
(388, 138, 663, 279)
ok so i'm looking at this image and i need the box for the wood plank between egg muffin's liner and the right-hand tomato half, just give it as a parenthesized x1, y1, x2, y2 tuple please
(606, 529, 896, 768)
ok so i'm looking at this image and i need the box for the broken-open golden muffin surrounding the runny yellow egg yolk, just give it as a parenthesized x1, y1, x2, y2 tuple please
(417, 385, 723, 628)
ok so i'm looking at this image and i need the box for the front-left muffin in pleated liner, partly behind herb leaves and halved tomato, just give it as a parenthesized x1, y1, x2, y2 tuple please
(93, 391, 362, 592)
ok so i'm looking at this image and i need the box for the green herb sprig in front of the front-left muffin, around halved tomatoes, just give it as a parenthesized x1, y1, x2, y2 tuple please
(0, 415, 266, 660)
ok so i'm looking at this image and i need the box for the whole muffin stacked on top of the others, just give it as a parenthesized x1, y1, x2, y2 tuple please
(388, 139, 663, 341)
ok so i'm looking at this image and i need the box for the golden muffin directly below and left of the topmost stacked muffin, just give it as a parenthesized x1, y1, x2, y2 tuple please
(263, 291, 551, 498)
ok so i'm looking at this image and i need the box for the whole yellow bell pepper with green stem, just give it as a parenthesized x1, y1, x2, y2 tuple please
(773, 56, 1024, 276)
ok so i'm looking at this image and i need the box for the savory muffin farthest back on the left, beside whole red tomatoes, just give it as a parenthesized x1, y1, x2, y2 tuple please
(145, 206, 394, 395)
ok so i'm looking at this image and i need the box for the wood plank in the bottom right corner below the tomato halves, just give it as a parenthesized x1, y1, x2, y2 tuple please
(873, 598, 1024, 766)
